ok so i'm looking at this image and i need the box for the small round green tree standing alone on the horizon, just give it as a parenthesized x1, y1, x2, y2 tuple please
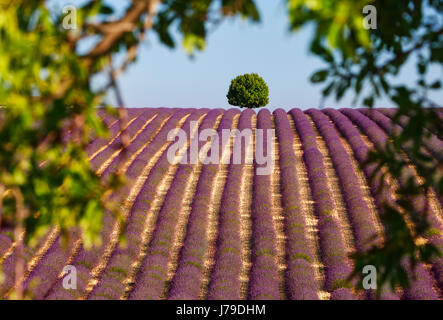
(226, 73, 269, 108)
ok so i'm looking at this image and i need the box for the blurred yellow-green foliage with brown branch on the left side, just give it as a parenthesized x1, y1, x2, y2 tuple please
(0, 1, 112, 249)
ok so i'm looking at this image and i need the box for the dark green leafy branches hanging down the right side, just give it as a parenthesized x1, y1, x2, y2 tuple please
(287, 0, 443, 293)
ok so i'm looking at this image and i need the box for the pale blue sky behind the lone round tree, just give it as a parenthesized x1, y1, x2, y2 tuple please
(55, 0, 443, 109)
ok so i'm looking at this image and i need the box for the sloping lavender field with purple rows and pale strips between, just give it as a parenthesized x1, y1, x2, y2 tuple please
(0, 108, 443, 299)
